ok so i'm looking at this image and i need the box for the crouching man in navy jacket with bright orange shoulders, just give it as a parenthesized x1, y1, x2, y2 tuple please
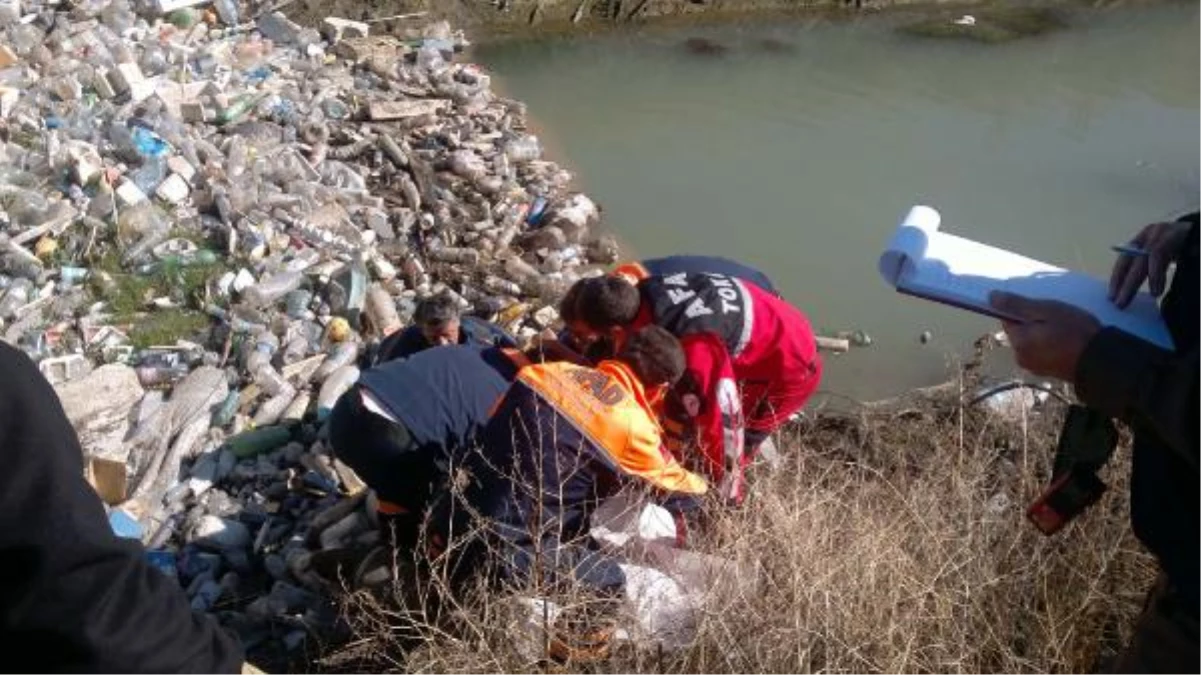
(430, 327, 707, 597)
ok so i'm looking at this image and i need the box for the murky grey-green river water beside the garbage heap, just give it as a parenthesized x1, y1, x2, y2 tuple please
(477, 6, 1201, 399)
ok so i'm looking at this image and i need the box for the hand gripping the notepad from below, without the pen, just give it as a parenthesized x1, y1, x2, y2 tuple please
(988, 292, 1101, 382)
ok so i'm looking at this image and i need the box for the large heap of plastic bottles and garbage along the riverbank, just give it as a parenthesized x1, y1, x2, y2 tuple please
(0, 0, 617, 649)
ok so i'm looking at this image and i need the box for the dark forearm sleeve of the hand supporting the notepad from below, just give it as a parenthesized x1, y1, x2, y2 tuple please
(1076, 327, 1201, 471)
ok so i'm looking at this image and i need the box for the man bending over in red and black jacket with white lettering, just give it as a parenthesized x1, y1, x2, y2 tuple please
(563, 273, 821, 503)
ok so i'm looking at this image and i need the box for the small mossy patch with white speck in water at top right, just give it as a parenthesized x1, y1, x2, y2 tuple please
(900, 7, 1068, 44)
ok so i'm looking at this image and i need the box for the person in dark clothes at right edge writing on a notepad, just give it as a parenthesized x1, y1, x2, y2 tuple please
(993, 208, 1201, 675)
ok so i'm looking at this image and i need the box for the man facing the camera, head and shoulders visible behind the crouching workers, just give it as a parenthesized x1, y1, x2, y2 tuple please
(375, 294, 516, 363)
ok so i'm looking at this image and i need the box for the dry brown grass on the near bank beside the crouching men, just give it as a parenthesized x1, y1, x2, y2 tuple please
(309, 374, 1153, 673)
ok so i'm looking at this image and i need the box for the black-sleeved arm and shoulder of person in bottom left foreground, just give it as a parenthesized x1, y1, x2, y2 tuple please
(0, 345, 243, 675)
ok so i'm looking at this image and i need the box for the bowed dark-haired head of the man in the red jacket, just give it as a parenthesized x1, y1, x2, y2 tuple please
(560, 276, 643, 350)
